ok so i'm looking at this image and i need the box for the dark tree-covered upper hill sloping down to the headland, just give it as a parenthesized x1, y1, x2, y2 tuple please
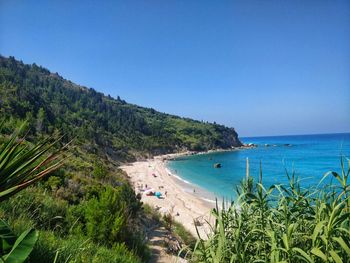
(0, 56, 241, 161)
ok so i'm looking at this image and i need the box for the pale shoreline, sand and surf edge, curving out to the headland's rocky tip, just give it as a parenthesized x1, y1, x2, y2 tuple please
(120, 145, 255, 239)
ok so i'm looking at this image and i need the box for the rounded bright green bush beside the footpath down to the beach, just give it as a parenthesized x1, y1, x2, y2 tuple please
(85, 184, 149, 260)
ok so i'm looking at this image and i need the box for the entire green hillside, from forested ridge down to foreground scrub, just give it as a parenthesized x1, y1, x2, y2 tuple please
(0, 56, 241, 262)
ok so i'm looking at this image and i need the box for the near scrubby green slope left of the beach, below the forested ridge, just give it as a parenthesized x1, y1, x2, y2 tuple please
(0, 126, 149, 263)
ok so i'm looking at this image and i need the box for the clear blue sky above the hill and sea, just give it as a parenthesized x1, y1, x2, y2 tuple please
(0, 0, 350, 136)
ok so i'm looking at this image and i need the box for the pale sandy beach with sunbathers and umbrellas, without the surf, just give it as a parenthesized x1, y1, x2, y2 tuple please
(121, 154, 215, 238)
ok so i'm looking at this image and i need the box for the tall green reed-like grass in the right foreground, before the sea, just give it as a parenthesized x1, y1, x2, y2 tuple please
(192, 159, 350, 263)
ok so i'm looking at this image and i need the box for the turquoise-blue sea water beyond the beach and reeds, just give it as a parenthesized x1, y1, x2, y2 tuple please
(168, 133, 350, 198)
